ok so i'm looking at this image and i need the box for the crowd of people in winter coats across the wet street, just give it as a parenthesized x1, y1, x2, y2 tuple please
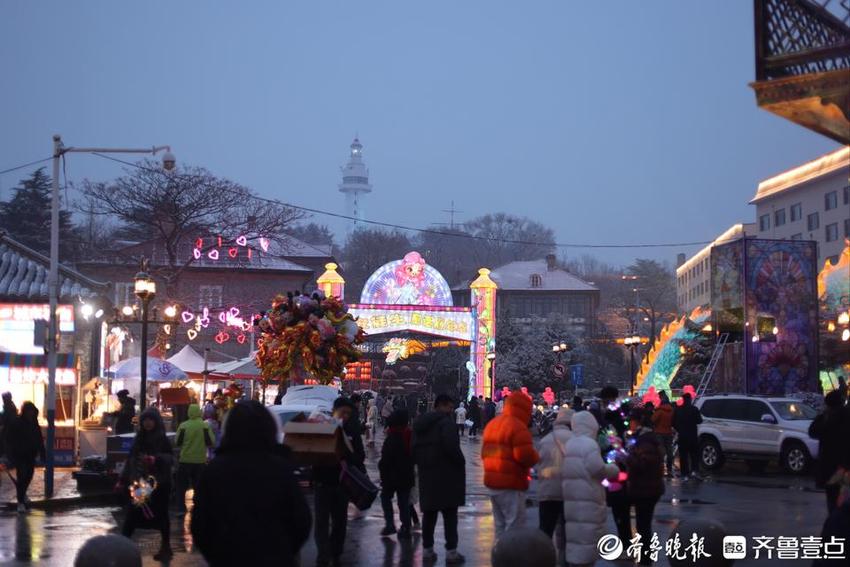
(0, 386, 850, 567)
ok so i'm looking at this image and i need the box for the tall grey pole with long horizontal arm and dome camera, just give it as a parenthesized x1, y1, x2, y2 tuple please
(44, 134, 176, 498)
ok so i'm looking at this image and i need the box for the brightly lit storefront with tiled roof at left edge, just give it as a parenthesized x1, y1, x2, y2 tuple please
(0, 235, 111, 466)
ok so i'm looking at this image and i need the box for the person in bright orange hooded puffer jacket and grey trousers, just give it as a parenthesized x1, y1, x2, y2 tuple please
(481, 390, 540, 538)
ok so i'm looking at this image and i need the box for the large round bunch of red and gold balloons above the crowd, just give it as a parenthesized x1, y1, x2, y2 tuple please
(255, 291, 365, 384)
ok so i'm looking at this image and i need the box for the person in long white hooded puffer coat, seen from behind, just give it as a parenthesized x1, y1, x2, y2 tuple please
(561, 411, 620, 567)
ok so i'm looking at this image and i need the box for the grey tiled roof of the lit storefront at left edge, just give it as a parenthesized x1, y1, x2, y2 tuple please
(0, 233, 107, 301)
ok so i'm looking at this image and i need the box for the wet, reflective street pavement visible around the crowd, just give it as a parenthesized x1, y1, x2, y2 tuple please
(0, 432, 826, 567)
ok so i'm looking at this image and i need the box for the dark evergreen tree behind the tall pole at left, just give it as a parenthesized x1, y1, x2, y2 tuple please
(0, 167, 75, 260)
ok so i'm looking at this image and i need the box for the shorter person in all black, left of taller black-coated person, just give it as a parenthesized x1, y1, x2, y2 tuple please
(378, 410, 416, 539)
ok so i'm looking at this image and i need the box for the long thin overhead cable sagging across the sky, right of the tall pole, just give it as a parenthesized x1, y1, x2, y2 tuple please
(93, 152, 714, 249)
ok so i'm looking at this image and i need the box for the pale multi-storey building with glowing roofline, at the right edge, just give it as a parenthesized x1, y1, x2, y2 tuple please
(749, 147, 850, 269)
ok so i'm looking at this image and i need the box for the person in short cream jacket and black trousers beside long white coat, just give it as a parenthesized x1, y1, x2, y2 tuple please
(536, 408, 575, 565)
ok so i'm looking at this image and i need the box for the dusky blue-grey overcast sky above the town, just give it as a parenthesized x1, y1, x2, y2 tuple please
(0, 0, 835, 263)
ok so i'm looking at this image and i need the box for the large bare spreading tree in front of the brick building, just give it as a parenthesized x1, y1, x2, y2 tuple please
(80, 160, 306, 297)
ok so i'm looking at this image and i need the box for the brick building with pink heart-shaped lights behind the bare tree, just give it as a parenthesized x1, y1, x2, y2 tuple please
(77, 236, 334, 361)
